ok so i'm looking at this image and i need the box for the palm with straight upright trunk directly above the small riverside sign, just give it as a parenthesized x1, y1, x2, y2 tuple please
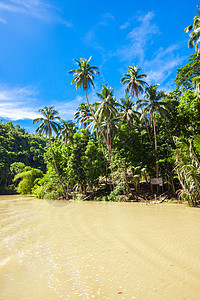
(142, 83, 167, 177)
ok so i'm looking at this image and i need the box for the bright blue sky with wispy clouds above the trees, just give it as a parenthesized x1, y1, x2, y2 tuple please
(0, 0, 200, 132)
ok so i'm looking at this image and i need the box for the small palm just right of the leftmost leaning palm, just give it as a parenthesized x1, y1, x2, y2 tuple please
(58, 120, 76, 161)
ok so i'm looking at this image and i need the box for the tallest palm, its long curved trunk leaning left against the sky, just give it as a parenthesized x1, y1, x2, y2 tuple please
(68, 56, 114, 157)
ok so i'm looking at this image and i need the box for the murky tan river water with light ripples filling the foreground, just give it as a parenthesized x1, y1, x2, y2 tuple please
(0, 196, 200, 300)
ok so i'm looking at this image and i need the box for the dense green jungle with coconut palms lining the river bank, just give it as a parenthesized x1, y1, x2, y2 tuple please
(0, 7, 200, 206)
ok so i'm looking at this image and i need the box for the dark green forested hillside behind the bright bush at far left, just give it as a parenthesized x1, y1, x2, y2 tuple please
(0, 122, 46, 193)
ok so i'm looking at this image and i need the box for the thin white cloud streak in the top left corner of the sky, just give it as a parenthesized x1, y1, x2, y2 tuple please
(0, 0, 73, 27)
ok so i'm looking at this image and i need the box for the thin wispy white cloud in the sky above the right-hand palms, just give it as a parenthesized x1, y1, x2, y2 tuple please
(114, 12, 186, 90)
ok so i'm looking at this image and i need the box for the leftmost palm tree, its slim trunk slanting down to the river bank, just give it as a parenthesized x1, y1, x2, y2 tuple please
(33, 106, 66, 198)
